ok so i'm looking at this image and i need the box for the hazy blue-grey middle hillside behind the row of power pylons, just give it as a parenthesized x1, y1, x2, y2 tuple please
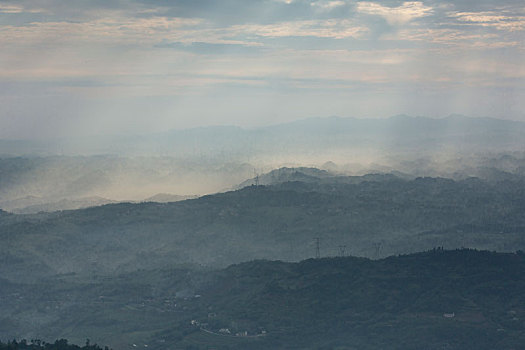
(0, 176, 525, 280)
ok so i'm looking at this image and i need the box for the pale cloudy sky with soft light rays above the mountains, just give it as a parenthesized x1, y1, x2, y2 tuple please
(0, 0, 525, 139)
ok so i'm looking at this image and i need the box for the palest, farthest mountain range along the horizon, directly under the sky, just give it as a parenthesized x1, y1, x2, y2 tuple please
(0, 115, 525, 156)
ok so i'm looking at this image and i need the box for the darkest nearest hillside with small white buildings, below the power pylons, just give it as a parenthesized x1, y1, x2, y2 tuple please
(0, 249, 525, 350)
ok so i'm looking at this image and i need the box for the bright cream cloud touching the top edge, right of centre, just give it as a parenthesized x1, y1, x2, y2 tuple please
(357, 1, 433, 24)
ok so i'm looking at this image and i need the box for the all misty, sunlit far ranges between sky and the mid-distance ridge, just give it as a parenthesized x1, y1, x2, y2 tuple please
(0, 116, 525, 205)
